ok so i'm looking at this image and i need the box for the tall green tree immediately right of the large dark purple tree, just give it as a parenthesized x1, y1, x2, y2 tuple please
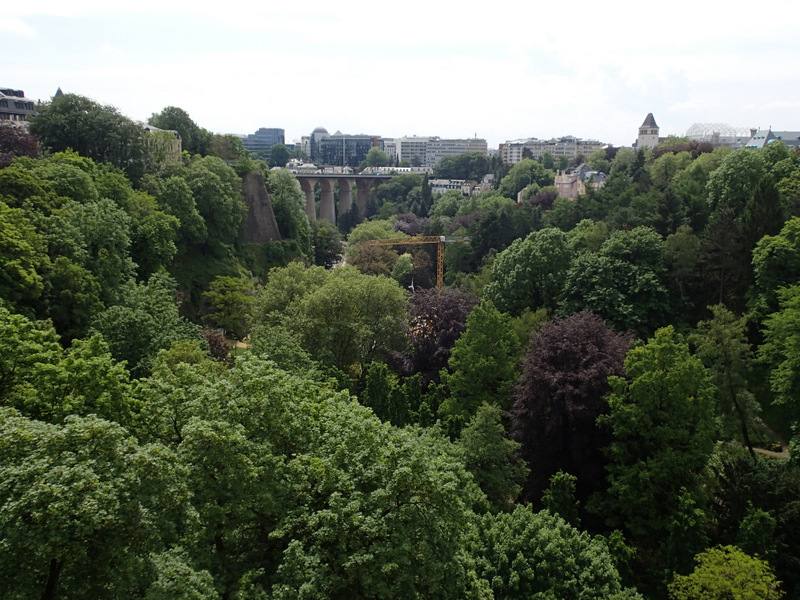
(598, 327, 716, 541)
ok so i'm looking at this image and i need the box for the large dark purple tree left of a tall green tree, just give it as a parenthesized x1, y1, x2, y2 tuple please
(509, 312, 633, 516)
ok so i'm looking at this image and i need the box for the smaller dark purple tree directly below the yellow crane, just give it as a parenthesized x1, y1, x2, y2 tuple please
(402, 288, 477, 384)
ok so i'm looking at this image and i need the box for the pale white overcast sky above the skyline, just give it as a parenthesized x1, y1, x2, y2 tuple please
(6, 0, 800, 147)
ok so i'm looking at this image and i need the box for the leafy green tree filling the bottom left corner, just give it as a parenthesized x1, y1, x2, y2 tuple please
(0, 408, 185, 600)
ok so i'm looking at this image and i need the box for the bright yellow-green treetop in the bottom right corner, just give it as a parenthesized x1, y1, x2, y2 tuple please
(669, 546, 783, 600)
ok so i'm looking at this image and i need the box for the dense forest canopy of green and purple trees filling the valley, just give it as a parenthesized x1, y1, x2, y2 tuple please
(0, 94, 800, 600)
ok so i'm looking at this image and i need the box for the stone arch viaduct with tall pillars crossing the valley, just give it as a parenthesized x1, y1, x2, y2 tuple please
(294, 173, 397, 224)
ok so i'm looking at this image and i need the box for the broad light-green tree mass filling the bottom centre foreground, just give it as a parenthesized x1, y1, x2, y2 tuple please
(140, 355, 485, 599)
